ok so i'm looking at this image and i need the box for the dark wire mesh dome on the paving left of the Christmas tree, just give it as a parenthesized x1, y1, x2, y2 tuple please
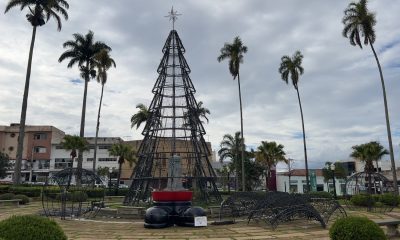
(42, 168, 105, 219)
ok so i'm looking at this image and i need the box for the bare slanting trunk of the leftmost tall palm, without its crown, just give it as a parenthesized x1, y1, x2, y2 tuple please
(14, 26, 36, 184)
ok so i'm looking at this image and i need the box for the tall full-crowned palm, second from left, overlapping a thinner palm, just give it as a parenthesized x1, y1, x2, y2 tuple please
(58, 31, 111, 177)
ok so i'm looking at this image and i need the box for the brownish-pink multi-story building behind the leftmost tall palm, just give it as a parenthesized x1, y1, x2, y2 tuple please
(0, 123, 65, 181)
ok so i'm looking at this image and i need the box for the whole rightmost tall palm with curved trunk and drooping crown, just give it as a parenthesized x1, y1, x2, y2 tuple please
(342, 0, 399, 194)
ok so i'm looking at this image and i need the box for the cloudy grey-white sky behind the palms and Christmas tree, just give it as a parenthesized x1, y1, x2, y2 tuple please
(0, 0, 400, 168)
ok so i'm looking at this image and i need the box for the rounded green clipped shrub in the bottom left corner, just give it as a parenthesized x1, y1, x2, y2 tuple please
(0, 215, 67, 240)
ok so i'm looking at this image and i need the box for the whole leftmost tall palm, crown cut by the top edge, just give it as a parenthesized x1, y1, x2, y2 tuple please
(4, 0, 69, 184)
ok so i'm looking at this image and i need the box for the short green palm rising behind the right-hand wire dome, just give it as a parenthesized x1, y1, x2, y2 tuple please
(350, 141, 388, 193)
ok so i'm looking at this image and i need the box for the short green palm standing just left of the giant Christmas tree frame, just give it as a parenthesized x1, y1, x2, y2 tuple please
(108, 143, 136, 193)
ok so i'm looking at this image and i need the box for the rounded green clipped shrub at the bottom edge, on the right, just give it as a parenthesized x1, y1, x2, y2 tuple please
(329, 217, 387, 240)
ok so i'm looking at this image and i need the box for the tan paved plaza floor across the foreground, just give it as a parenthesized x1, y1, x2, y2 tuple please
(0, 202, 400, 240)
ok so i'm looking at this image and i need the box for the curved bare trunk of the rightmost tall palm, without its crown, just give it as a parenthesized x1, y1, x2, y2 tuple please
(368, 38, 399, 195)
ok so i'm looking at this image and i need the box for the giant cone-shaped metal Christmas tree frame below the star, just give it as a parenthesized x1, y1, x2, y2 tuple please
(124, 30, 222, 205)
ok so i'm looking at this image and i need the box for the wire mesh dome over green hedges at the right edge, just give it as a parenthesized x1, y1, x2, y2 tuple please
(345, 172, 399, 212)
